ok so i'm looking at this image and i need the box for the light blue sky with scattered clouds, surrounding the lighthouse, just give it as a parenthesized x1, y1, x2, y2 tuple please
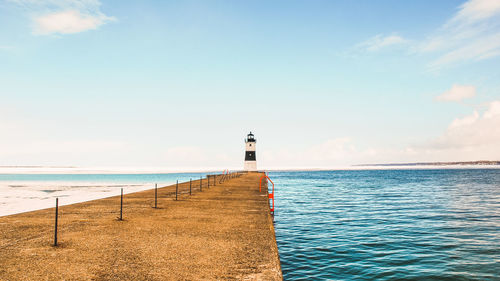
(0, 0, 500, 169)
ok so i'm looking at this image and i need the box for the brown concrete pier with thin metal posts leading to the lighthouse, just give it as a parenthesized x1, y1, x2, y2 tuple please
(0, 173, 282, 280)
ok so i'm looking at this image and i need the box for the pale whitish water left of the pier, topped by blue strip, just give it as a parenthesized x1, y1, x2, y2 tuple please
(0, 173, 211, 216)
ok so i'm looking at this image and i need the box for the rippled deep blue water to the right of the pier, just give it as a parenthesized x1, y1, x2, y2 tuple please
(269, 169, 500, 280)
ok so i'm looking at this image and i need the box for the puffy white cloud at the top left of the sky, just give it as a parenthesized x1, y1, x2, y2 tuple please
(10, 0, 115, 35)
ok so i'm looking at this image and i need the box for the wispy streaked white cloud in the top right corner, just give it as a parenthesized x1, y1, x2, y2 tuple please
(417, 0, 500, 70)
